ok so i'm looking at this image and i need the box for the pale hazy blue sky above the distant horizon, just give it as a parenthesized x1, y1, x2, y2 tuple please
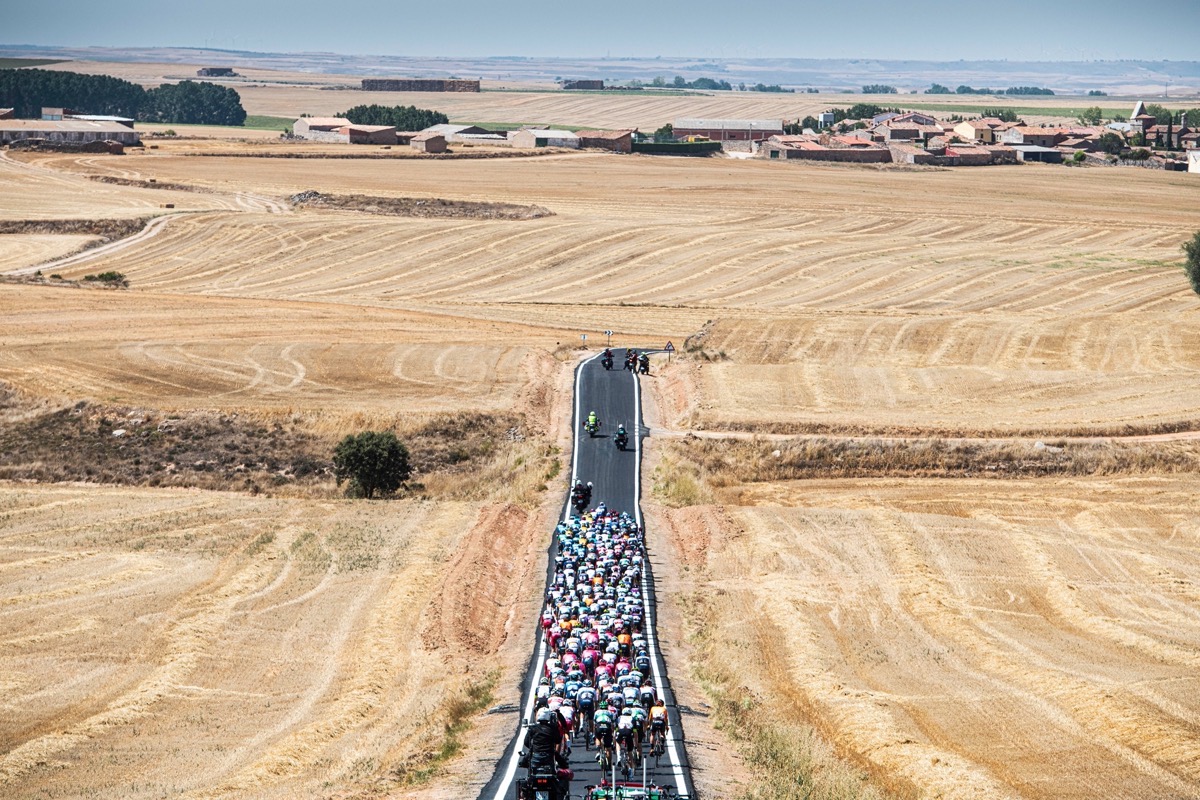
(7, 0, 1200, 60)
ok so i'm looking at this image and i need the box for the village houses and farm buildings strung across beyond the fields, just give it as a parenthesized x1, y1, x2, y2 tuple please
(0, 68, 1200, 174)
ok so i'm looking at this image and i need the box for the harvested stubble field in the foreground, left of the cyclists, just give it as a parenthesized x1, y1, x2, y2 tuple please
(0, 486, 544, 798)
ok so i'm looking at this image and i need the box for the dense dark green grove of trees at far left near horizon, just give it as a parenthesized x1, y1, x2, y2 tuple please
(0, 70, 246, 125)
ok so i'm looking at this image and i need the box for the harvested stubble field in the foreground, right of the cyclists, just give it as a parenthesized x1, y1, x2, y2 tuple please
(655, 476, 1200, 799)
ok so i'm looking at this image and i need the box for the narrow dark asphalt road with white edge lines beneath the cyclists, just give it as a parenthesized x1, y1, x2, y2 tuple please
(479, 350, 695, 800)
